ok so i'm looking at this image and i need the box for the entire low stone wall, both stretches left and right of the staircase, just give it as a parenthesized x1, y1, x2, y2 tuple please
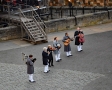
(0, 10, 112, 41)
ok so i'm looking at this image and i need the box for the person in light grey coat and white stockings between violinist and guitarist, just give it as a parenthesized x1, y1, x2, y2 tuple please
(53, 37, 62, 62)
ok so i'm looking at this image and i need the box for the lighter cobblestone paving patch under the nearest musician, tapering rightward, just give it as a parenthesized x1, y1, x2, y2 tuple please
(0, 63, 104, 90)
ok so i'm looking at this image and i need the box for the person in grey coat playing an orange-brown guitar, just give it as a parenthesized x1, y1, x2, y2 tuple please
(62, 33, 73, 57)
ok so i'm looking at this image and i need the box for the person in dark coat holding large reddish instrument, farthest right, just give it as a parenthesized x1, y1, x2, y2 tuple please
(74, 27, 85, 52)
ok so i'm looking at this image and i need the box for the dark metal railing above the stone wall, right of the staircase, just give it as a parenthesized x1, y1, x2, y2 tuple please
(50, 6, 112, 19)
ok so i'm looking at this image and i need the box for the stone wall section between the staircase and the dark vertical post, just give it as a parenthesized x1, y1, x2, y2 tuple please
(45, 17, 76, 33)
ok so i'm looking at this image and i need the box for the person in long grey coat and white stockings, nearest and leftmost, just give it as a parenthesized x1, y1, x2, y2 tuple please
(26, 55, 35, 83)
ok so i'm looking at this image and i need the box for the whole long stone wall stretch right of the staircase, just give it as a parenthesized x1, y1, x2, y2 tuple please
(45, 10, 112, 33)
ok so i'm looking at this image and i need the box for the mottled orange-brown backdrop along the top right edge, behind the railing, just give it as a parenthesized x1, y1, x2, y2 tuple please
(48, 0, 112, 7)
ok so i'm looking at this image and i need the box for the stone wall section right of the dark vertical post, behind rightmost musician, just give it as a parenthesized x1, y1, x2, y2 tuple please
(77, 12, 108, 27)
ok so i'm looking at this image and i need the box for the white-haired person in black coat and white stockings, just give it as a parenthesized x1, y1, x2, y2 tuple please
(42, 47, 50, 73)
